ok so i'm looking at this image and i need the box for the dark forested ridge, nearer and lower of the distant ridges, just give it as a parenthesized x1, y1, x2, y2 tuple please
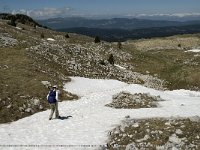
(59, 24, 200, 42)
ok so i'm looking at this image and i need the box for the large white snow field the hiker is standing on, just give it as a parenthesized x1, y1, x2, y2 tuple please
(0, 77, 200, 149)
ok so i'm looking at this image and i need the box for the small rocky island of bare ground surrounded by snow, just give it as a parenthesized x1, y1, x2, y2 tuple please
(106, 92, 163, 109)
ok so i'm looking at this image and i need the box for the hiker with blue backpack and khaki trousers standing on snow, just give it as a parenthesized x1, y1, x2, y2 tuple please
(47, 85, 60, 120)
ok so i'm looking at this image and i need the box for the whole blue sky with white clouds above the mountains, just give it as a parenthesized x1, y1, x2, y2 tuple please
(0, 0, 200, 18)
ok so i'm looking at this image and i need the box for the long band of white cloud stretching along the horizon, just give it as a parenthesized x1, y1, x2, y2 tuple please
(12, 6, 200, 19)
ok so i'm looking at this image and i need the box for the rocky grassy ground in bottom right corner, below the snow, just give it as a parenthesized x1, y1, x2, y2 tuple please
(108, 117, 200, 150)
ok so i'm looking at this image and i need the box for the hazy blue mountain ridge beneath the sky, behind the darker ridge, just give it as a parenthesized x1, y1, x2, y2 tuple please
(37, 17, 200, 29)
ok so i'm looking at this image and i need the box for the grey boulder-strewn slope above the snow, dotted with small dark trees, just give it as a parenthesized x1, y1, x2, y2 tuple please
(26, 35, 165, 89)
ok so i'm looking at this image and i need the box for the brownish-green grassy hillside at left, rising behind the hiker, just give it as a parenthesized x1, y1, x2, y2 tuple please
(0, 24, 77, 123)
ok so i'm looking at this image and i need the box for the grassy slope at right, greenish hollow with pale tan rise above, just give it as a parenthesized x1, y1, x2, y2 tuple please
(119, 34, 200, 90)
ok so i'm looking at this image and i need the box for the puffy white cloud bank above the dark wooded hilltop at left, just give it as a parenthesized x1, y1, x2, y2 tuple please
(12, 7, 72, 19)
